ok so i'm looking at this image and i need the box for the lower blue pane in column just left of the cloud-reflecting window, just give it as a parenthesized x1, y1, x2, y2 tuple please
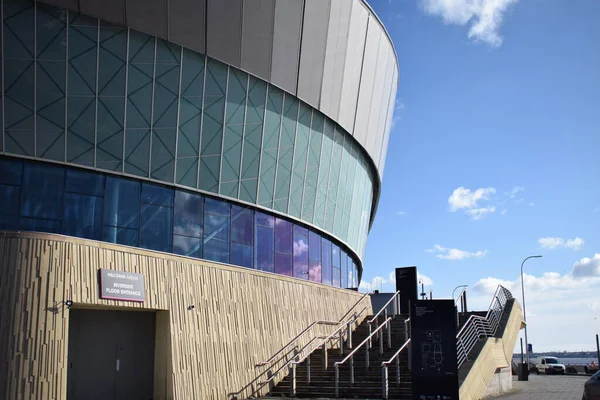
(140, 204, 173, 252)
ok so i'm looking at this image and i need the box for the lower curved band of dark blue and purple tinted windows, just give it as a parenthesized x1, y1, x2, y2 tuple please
(0, 157, 358, 288)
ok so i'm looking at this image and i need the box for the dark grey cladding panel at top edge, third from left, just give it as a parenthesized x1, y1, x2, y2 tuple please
(125, 0, 167, 39)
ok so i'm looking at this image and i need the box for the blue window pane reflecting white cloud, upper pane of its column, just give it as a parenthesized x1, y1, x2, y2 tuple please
(173, 191, 204, 238)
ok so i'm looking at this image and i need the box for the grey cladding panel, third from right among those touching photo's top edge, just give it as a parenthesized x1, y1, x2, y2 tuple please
(298, 0, 331, 108)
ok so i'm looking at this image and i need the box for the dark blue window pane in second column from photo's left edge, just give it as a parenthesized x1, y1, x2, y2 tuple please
(21, 163, 65, 219)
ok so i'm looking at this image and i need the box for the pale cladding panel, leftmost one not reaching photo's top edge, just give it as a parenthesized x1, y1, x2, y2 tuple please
(353, 16, 382, 147)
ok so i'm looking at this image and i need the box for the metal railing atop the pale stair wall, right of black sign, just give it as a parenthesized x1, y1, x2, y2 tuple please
(456, 285, 513, 368)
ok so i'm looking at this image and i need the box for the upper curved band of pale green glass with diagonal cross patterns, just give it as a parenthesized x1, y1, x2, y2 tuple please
(0, 0, 375, 256)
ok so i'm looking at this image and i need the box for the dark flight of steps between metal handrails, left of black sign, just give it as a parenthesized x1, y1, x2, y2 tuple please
(267, 315, 412, 399)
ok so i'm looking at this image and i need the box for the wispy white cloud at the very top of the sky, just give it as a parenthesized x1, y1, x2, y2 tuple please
(421, 0, 518, 47)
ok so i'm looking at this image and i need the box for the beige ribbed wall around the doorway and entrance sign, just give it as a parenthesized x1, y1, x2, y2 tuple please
(0, 232, 372, 400)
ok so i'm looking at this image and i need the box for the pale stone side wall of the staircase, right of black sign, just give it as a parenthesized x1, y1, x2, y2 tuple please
(460, 300, 523, 400)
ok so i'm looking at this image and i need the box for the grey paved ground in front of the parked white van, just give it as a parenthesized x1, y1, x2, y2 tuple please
(494, 375, 589, 400)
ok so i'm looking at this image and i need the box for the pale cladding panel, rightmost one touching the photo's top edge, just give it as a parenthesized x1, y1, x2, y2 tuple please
(338, 0, 369, 133)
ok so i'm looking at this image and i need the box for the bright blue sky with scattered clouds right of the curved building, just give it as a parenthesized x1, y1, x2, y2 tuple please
(362, 0, 600, 351)
